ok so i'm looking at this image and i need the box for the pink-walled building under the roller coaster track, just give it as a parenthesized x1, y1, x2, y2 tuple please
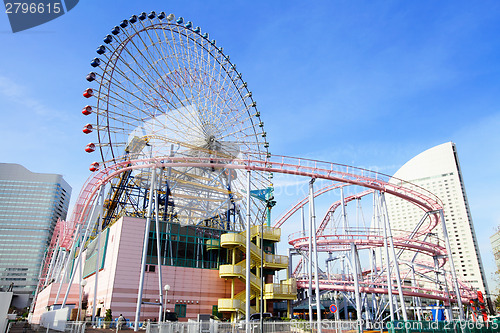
(32, 217, 239, 323)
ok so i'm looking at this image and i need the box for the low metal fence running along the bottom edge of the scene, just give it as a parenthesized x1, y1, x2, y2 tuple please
(7, 320, 500, 333)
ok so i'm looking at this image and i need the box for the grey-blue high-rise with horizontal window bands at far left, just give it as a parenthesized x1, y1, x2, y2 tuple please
(0, 163, 71, 308)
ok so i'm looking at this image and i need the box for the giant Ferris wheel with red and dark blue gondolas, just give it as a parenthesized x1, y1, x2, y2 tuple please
(82, 12, 272, 228)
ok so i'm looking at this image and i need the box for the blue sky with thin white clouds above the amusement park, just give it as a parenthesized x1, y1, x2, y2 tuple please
(0, 0, 500, 289)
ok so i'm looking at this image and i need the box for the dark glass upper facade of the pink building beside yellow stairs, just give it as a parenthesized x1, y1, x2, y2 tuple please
(147, 221, 227, 269)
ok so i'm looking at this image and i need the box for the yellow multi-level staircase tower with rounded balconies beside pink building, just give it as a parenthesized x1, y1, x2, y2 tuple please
(218, 226, 297, 321)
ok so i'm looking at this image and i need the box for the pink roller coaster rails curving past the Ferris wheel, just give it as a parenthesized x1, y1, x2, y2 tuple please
(38, 156, 469, 300)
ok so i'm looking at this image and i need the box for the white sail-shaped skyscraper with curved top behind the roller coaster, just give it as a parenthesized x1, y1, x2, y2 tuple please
(387, 142, 488, 293)
